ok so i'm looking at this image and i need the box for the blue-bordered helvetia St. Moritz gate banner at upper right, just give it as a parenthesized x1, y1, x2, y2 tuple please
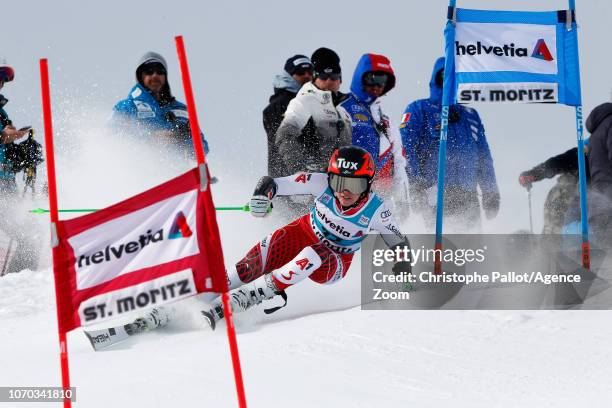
(444, 8, 582, 106)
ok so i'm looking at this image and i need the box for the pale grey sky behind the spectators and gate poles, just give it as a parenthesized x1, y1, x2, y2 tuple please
(0, 0, 612, 232)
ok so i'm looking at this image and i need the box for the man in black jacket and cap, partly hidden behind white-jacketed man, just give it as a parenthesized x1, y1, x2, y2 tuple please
(263, 54, 312, 177)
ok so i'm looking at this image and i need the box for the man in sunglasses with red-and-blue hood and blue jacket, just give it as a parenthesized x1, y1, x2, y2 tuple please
(339, 54, 409, 218)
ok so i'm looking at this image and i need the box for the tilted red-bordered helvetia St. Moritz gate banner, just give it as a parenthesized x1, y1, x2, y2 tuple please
(54, 168, 225, 332)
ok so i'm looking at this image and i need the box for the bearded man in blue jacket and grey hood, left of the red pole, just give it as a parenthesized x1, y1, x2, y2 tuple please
(113, 52, 208, 153)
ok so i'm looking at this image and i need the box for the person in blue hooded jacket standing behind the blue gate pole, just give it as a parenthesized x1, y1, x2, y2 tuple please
(400, 58, 500, 229)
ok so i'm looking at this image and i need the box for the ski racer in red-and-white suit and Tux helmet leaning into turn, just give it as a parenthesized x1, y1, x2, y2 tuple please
(202, 146, 411, 329)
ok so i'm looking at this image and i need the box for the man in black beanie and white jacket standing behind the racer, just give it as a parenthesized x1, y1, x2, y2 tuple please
(275, 47, 351, 218)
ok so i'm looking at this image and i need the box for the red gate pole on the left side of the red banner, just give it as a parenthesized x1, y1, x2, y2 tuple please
(40, 58, 72, 408)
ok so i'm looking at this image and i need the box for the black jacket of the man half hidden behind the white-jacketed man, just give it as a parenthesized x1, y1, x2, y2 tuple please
(263, 88, 297, 177)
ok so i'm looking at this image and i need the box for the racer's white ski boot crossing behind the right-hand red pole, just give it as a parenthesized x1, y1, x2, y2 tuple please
(202, 274, 279, 330)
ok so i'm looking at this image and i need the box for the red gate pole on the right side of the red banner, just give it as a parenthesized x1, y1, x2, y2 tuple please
(174, 35, 247, 408)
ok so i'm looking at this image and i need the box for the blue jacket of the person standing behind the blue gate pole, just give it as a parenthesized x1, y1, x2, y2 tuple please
(400, 57, 499, 193)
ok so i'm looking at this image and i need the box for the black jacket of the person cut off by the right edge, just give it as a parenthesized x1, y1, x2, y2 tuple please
(586, 102, 612, 201)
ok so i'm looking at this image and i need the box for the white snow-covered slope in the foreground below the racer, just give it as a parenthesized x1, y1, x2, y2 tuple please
(0, 271, 612, 407)
